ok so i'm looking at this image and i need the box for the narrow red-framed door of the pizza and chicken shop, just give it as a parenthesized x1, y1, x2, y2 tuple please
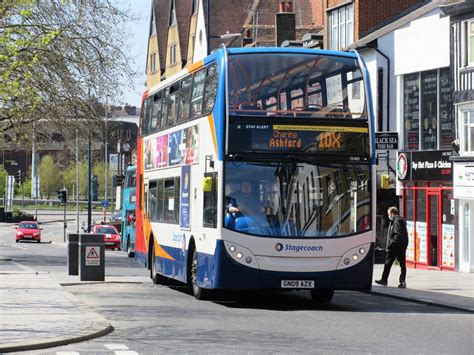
(426, 189, 442, 268)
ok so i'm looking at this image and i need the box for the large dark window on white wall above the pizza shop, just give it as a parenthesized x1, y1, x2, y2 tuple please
(403, 68, 454, 151)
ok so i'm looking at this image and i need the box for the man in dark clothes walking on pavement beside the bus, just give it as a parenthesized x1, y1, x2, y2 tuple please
(375, 207, 408, 288)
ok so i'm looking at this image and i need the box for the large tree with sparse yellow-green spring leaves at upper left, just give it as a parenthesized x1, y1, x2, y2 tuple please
(0, 0, 139, 139)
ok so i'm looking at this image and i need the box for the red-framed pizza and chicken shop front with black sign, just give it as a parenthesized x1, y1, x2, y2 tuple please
(397, 150, 456, 270)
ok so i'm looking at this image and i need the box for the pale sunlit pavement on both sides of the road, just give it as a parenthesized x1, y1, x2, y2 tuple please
(0, 262, 474, 353)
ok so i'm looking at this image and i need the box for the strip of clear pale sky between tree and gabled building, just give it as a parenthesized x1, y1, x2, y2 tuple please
(120, 0, 152, 107)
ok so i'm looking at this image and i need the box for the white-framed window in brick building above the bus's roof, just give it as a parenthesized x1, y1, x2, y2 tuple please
(328, 3, 354, 50)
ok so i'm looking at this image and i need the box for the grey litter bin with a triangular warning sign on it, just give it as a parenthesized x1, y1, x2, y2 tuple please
(79, 234, 105, 281)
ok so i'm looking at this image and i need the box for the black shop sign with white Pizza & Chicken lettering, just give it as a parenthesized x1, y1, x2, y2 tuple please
(410, 150, 453, 181)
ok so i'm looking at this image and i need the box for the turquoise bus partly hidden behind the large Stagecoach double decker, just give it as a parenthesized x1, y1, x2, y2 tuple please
(120, 165, 137, 258)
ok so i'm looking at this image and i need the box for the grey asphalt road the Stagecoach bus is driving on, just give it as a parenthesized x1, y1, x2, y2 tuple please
(0, 219, 474, 354)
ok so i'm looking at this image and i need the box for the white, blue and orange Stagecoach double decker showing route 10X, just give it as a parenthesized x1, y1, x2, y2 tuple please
(135, 47, 376, 302)
